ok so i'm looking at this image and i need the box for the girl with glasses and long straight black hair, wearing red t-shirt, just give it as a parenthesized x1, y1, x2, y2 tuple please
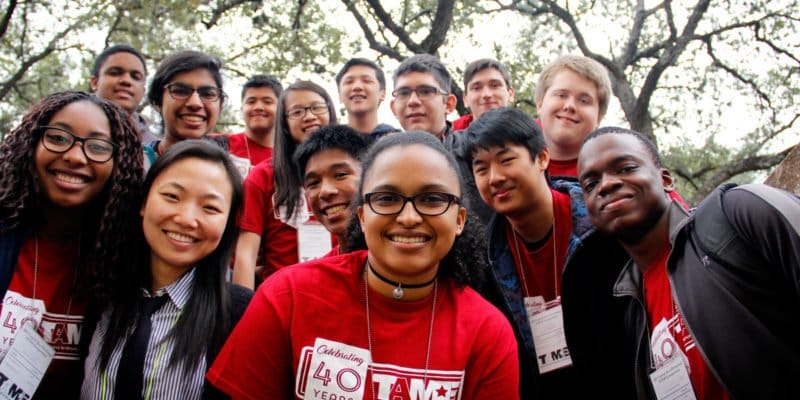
(233, 81, 336, 289)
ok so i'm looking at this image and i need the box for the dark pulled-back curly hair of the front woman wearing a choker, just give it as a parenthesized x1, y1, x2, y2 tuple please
(345, 131, 488, 290)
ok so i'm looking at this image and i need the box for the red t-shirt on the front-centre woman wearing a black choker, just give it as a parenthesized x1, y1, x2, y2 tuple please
(206, 251, 519, 400)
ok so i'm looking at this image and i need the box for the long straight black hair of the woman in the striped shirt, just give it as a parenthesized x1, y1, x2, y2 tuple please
(100, 140, 244, 373)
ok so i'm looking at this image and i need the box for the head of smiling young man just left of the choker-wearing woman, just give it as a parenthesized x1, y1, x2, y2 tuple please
(294, 125, 368, 255)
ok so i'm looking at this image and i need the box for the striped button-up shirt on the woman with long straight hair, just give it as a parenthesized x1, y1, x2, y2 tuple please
(81, 269, 206, 399)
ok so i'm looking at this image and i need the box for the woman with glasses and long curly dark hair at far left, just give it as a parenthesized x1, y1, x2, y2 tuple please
(0, 92, 142, 398)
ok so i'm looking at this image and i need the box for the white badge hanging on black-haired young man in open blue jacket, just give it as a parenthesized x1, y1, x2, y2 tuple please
(525, 296, 572, 374)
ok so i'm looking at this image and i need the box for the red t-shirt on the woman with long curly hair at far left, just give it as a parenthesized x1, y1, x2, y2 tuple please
(0, 239, 86, 398)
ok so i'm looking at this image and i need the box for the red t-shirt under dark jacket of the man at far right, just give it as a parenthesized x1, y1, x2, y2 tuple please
(643, 246, 730, 400)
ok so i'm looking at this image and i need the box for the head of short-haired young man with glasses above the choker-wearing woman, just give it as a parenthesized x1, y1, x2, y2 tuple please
(391, 54, 456, 141)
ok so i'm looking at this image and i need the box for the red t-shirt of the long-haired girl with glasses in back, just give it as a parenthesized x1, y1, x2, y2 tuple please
(239, 158, 299, 277)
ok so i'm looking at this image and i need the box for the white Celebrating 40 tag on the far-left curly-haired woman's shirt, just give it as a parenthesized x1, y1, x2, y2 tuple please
(0, 290, 46, 359)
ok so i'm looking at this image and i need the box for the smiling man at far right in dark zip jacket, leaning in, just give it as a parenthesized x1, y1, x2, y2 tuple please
(564, 127, 800, 400)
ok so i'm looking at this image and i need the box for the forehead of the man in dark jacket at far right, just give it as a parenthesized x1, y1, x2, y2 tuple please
(578, 133, 655, 175)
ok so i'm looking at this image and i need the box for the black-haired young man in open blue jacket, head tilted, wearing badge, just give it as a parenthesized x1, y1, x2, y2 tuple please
(463, 108, 591, 398)
